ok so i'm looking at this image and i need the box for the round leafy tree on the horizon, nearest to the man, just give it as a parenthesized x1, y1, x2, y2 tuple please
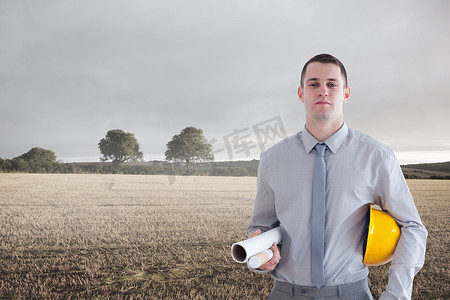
(165, 127, 214, 171)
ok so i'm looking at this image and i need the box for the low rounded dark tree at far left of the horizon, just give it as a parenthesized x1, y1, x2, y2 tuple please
(12, 147, 56, 173)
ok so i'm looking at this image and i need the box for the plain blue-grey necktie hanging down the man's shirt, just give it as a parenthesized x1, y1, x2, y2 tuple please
(311, 144, 327, 288)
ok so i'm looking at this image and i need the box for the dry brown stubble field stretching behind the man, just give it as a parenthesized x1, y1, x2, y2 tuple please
(0, 174, 450, 299)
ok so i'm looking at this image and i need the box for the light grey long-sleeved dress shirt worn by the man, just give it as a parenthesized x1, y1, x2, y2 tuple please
(248, 123, 427, 299)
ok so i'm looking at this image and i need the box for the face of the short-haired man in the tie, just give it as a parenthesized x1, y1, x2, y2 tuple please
(298, 62, 350, 124)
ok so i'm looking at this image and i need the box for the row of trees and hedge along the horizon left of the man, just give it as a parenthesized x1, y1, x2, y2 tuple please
(0, 127, 256, 176)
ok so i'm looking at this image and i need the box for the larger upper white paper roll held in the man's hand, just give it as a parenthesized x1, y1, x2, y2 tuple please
(231, 227, 282, 263)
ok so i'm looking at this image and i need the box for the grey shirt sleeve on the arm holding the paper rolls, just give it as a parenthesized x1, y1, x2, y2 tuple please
(247, 152, 280, 273)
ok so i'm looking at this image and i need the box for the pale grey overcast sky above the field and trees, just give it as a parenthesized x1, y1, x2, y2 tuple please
(0, 0, 450, 164)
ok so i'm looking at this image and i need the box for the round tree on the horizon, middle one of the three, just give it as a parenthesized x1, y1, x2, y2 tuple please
(98, 129, 144, 163)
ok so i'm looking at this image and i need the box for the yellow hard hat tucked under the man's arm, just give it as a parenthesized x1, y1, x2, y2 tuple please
(363, 204, 400, 266)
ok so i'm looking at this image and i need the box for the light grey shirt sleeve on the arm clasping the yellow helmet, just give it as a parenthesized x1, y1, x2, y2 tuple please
(379, 154, 428, 300)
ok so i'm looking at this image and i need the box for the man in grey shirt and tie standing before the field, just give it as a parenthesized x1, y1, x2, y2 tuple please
(249, 54, 427, 300)
